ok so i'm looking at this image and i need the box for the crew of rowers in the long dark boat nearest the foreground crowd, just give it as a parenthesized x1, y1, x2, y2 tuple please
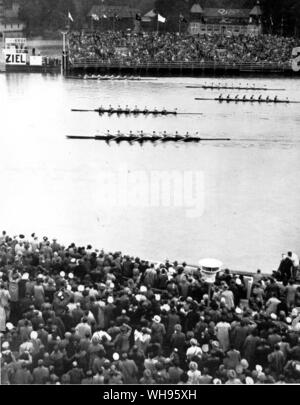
(104, 130, 201, 141)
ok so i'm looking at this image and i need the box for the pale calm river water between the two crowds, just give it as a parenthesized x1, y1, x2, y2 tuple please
(0, 74, 300, 272)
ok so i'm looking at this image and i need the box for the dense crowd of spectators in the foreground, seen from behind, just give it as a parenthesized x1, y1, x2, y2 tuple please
(0, 231, 300, 385)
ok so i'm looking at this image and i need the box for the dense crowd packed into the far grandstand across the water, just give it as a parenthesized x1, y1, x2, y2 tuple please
(68, 32, 297, 65)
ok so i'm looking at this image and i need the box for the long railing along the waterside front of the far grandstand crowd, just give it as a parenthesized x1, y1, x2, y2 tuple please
(69, 59, 291, 71)
